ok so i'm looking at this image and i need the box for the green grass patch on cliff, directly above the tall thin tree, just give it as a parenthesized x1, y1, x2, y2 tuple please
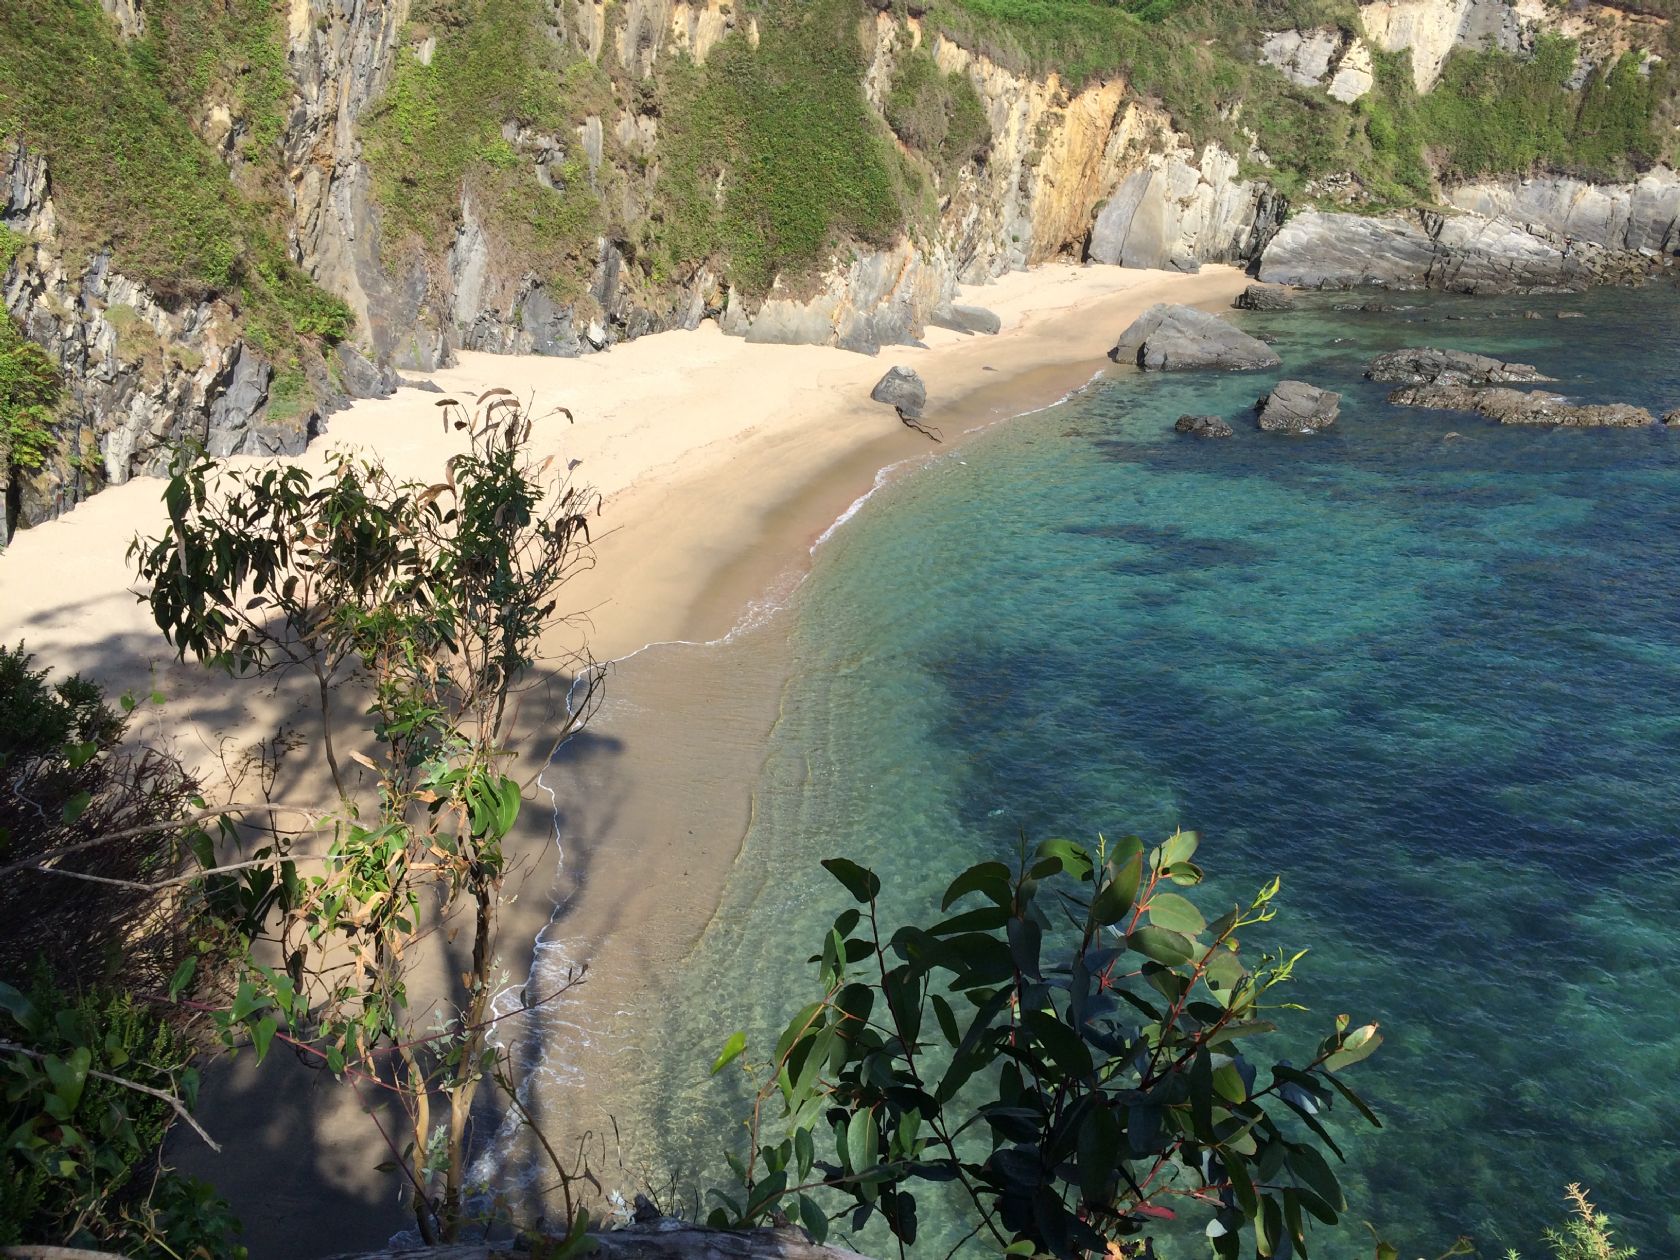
(363, 0, 612, 292)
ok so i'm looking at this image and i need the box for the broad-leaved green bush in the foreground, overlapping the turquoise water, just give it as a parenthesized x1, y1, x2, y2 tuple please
(711, 832, 1383, 1260)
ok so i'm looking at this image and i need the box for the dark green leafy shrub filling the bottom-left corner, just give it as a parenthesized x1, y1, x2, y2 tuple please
(0, 978, 245, 1260)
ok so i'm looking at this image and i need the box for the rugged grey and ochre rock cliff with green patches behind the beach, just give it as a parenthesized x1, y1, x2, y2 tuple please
(0, 0, 1680, 537)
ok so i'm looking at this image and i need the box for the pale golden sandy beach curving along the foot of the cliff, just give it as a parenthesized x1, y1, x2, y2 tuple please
(0, 265, 1247, 1260)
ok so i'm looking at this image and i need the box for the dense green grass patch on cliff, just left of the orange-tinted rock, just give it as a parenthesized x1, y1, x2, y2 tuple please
(652, 0, 926, 292)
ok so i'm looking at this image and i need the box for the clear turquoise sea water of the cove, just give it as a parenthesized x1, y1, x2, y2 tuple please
(618, 289, 1680, 1257)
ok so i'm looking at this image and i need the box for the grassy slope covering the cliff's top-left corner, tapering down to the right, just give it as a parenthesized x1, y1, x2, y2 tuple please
(0, 0, 351, 356)
